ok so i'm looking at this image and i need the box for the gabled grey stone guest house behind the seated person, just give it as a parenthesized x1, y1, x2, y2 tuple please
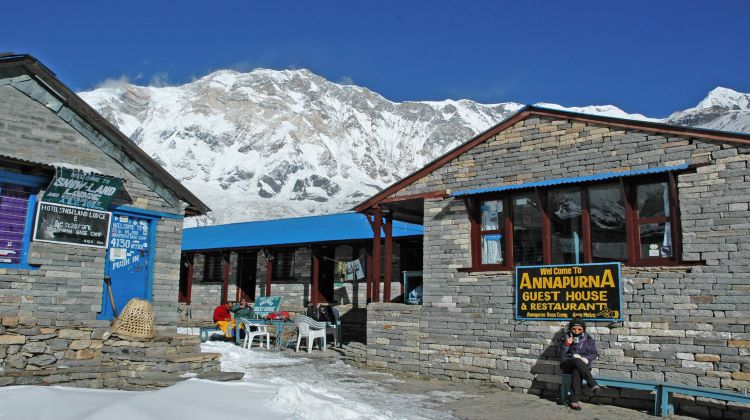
(355, 106, 750, 417)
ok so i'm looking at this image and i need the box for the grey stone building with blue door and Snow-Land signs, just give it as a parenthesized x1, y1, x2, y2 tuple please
(0, 54, 216, 387)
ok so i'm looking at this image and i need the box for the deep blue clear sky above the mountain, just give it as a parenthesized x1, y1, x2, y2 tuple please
(0, 0, 750, 117)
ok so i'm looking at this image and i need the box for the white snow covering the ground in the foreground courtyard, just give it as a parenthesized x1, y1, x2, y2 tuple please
(0, 342, 467, 420)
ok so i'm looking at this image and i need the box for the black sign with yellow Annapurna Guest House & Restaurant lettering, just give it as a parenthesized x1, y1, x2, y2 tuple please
(516, 263, 622, 321)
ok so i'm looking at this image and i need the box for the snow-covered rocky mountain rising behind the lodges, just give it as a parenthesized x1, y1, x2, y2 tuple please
(81, 69, 747, 224)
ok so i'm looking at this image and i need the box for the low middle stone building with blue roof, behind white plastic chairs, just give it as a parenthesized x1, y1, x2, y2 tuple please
(179, 213, 422, 332)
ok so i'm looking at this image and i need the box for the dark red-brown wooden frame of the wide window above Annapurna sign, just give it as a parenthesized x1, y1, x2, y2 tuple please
(472, 171, 683, 271)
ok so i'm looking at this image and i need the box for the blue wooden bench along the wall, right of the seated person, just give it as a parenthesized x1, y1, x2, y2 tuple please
(596, 377, 750, 417)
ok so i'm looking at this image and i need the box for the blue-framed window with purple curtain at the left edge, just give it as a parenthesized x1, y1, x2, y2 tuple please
(0, 171, 43, 268)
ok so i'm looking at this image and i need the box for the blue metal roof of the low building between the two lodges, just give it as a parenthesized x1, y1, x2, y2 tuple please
(182, 213, 422, 251)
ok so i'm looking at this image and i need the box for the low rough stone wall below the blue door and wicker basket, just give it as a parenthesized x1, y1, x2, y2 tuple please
(0, 317, 221, 389)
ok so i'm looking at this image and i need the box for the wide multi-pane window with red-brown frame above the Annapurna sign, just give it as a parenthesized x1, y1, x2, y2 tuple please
(472, 173, 680, 270)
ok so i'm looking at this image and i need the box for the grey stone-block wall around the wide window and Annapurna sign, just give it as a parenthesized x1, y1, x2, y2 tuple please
(368, 118, 750, 416)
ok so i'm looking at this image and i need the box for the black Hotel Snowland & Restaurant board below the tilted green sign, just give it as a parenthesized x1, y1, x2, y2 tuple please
(34, 202, 112, 248)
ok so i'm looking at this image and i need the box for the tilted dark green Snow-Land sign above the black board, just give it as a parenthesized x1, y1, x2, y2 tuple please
(41, 168, 122, 210)
